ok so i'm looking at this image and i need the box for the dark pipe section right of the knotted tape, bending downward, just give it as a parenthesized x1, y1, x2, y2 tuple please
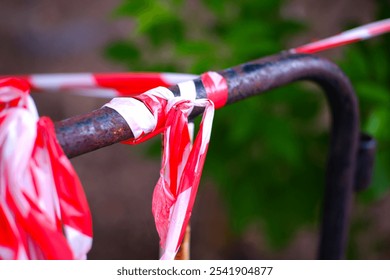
(216, 53, 359, 259)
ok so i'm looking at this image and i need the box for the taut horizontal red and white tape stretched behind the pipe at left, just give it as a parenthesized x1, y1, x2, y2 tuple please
(1, 72, 198, 98)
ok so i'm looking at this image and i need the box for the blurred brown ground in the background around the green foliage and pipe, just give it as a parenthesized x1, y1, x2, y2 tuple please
(0, 0, 390, 259)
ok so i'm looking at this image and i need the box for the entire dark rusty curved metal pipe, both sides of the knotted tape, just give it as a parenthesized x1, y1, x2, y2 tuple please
(56, 52, 359, 259)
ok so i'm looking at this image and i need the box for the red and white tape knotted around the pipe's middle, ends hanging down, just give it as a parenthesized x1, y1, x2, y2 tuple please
(105, 72, 227, 259)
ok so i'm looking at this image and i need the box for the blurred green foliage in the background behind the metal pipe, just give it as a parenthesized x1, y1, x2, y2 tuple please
(106, 0, 390, 247)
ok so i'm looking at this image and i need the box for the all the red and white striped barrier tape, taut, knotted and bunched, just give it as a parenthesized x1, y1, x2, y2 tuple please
(0, 19, 390, 259)
